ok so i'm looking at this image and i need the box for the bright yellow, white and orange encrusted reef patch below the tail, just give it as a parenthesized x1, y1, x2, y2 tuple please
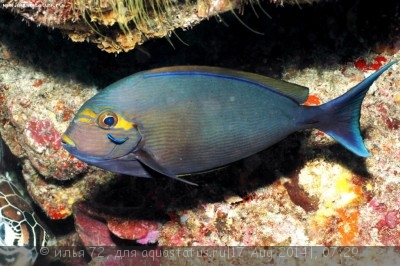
(299, 160, 366, 245)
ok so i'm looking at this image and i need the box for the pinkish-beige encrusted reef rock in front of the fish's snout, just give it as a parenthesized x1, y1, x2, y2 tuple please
(0, 56, 116, 219)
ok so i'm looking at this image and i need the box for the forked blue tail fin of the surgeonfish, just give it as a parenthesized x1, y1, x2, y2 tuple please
(316, 61, 398, 157)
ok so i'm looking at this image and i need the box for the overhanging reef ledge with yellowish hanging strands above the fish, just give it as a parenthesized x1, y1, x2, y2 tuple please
(1, 0, 324, 53)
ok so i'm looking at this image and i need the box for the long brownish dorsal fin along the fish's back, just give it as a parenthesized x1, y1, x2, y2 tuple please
(145, 66, 309, 104)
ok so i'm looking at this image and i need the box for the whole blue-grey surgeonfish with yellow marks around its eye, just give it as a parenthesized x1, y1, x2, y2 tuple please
(61, 61, 397, 183)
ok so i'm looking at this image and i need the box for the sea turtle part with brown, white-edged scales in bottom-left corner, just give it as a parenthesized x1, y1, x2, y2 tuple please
(0, 173, 50, 266)
